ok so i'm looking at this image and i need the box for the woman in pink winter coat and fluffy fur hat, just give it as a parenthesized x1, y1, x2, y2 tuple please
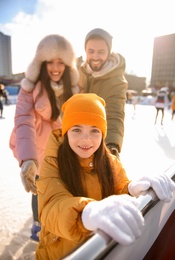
(10, 35, 79, 241)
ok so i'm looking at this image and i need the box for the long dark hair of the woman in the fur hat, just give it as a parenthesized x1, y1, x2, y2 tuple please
(36, 61, 73, 121)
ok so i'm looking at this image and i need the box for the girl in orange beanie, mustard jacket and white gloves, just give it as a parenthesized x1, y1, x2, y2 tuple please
(36, 93, 175, 260)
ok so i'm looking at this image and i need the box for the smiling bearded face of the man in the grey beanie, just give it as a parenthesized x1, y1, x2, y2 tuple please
(85, 39, 109, 71)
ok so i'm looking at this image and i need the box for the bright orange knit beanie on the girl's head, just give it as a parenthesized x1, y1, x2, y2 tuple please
(62, 93, 107, 138)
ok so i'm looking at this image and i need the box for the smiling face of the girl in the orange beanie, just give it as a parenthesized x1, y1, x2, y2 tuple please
(67, 125, 102, 158)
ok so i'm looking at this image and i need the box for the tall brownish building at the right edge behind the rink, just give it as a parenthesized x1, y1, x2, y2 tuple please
(151, 34, 175, 92)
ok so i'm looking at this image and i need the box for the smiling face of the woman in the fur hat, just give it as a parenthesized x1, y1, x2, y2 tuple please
(46, 59, 65, 82)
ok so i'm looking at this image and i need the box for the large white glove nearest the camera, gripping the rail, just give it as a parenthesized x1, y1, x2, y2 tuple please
(82, 194, 144, 245)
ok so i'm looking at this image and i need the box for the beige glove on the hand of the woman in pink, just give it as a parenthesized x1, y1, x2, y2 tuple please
(20, 160, 37, 194)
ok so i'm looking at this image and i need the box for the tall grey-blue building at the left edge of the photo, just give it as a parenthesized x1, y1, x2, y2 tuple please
(0, 32, 12, 78)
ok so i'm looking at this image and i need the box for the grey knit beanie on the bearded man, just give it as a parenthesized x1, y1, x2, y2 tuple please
(85, 28, 112, 52)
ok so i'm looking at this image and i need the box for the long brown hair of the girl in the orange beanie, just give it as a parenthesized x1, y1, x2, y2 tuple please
(57, 134, 115, 198)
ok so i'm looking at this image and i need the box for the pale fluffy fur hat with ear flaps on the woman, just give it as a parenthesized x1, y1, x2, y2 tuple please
(21, 34, 79, 91)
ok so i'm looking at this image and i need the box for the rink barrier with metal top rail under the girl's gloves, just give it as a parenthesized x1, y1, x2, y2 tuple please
(63, 164, 175, 260)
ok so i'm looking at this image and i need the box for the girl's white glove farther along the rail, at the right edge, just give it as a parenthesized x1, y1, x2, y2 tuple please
(128, 174, 175, 202)
